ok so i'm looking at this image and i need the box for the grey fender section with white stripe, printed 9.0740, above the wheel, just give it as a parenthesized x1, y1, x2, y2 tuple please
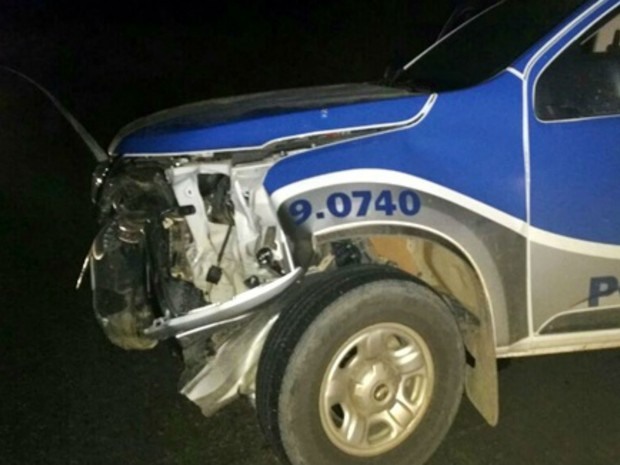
(272, 170, 527, 346)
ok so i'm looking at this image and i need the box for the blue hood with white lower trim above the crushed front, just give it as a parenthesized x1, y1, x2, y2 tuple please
(109, 84, 426, 155)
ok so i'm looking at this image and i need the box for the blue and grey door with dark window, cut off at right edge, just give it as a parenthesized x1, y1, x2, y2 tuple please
(525, 2, 620, 337)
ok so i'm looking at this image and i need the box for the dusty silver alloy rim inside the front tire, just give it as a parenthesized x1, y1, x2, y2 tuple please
(319, 323, 434, 457)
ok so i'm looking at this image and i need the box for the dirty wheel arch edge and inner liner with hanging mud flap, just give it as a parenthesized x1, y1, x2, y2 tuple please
(306, 222, 508, 425)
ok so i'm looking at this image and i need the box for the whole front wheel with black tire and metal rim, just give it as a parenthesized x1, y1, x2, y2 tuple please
(256, 265, 465, 465)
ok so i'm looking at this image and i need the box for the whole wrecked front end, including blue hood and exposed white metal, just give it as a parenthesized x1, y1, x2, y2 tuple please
(83, 84, 422, 415)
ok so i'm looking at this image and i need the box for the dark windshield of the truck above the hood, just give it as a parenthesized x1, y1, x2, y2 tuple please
(394, 0, 586, 92)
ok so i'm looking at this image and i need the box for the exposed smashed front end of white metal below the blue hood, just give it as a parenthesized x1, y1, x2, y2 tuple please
(89, 151, 301, 413)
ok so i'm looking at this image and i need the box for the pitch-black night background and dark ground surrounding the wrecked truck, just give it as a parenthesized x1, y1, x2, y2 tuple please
(0, 0, 620, 465)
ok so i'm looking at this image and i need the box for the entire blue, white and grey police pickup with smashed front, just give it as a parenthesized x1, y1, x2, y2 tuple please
(83, 0, 620, 465)
